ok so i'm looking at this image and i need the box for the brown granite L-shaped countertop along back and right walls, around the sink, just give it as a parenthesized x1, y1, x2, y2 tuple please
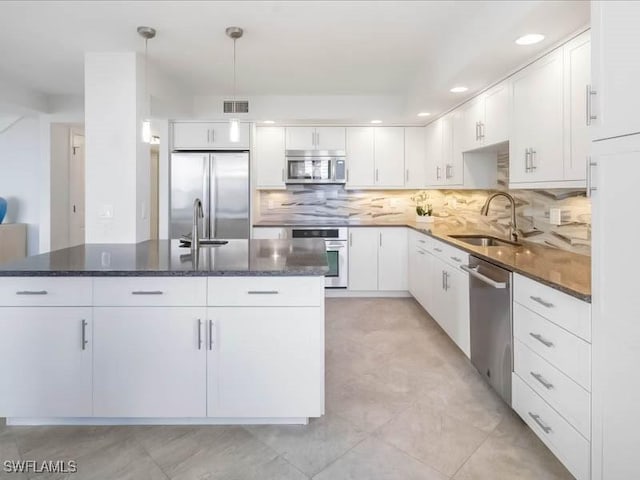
(254, 218, 591, 302)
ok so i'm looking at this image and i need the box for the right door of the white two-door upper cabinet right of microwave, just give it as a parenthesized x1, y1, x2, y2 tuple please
(373, 127, 405, 188)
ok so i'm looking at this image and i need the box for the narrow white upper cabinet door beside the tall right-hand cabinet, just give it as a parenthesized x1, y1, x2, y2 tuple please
(563, 32, 591, 181)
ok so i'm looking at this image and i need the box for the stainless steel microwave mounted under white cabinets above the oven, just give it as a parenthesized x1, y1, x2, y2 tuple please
(286, 150, 347, 184)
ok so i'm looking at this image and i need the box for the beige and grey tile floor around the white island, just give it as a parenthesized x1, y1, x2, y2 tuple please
(0, 299, 572, 480)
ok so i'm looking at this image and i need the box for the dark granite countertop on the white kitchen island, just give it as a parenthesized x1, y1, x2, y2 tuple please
(0, 239, 329, 277)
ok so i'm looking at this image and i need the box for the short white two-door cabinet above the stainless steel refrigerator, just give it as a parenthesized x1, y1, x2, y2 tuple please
(173, 122, 250, 150)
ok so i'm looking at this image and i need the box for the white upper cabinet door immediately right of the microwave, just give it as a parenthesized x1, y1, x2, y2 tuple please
(346, 127, 375, 188)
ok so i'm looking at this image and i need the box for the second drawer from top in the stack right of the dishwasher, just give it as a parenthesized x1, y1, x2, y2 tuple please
(513, 303, 591, 391)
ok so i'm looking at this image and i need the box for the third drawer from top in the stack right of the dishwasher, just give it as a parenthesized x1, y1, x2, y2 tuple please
(513, 340, 591, 439)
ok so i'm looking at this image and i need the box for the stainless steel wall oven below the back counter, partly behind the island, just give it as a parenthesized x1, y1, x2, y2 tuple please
(287, 227, 349, 288)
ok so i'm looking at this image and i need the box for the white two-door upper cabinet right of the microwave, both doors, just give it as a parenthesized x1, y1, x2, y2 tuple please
(346, 127, 405, 188)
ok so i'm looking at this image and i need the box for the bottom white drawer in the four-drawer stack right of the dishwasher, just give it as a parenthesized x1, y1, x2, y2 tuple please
(513, 374, 591, 480)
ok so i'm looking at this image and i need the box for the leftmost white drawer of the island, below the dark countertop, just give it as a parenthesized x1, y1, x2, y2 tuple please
(0, 277, 92, 307)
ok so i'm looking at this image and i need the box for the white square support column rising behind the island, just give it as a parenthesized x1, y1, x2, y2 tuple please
(85, 52, 150, 243)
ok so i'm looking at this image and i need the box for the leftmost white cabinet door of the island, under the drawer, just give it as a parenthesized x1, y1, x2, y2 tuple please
(0, 307, 93, 417)
